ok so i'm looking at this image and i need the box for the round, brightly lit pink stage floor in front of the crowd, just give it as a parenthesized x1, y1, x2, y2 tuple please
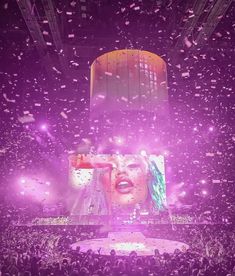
(71, 232, 189, 256)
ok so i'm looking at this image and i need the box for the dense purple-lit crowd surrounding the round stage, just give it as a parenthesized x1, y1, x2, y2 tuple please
(0, 219, 235, 276)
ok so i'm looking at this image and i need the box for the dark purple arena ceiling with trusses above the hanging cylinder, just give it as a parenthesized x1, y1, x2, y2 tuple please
(0, 0, 234, 77)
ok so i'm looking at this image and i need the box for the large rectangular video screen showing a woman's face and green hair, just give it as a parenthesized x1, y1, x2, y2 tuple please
(67, 154, 166, 216)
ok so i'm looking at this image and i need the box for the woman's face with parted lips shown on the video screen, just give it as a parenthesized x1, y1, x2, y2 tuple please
(101, 155, 148, 206)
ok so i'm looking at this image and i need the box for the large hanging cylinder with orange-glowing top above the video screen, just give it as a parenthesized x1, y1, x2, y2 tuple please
(90, 49, 168, 117)
